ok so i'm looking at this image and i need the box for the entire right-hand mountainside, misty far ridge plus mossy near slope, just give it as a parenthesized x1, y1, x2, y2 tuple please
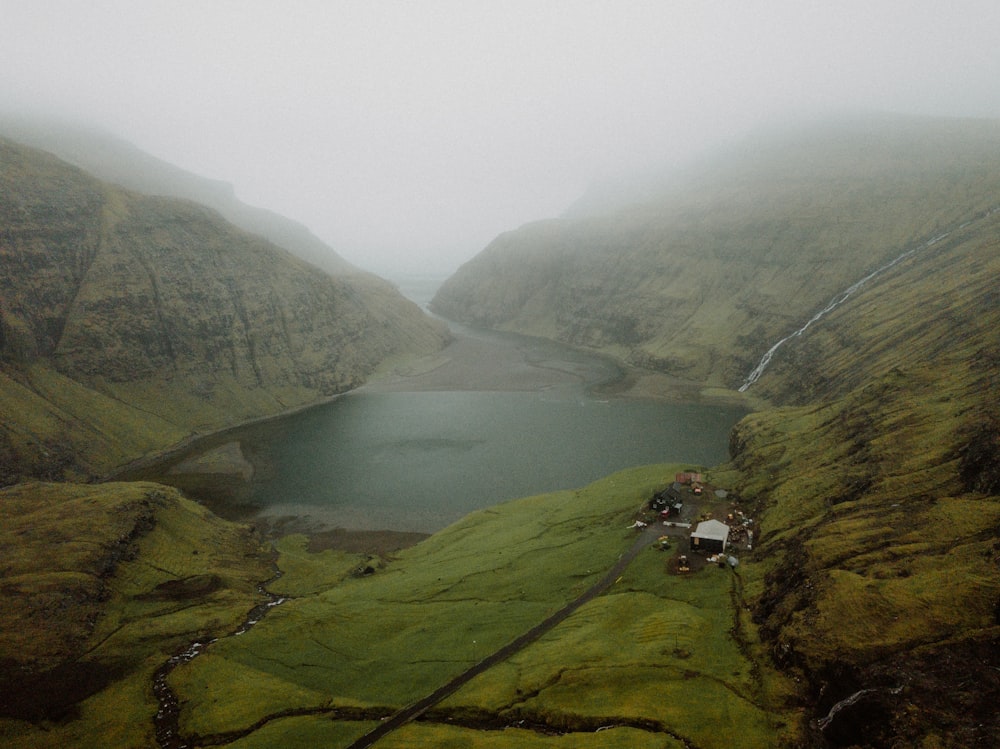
(432, 117, 1000, 749)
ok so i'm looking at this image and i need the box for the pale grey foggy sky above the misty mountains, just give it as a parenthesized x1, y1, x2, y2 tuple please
(0, 0, 1000, 272)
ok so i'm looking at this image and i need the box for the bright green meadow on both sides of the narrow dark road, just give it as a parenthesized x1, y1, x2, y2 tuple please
(171, 466, 797, 747)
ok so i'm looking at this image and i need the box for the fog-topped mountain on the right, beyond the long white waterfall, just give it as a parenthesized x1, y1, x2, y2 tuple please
(432, 117, 1000, 387)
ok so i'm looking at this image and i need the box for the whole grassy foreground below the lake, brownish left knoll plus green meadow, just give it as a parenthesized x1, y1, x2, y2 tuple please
(0, 465, 802, 749)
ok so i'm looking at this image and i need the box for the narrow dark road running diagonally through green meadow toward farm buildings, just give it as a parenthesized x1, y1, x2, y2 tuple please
(347, 525, 661, 749)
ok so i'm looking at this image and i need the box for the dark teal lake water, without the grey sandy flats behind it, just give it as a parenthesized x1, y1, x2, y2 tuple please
(234, 392, 745, 533)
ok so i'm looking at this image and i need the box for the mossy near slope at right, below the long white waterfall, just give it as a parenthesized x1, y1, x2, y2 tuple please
(720, 197, 1000, 747)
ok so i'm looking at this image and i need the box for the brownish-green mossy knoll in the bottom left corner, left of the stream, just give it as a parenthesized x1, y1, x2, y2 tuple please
(0, 483, 273, 747)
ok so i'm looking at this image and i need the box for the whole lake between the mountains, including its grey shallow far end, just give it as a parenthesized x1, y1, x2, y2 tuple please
(145, 281, 746, 533)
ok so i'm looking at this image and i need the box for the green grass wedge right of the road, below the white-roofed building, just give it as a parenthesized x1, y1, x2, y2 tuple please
(440, 551, 798, 747)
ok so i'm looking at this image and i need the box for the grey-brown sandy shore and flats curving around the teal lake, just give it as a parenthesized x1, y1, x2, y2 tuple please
(109, 318, 746, 556)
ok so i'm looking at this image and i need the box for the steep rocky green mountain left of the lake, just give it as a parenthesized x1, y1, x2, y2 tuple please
(0, 141, 446, 480)
